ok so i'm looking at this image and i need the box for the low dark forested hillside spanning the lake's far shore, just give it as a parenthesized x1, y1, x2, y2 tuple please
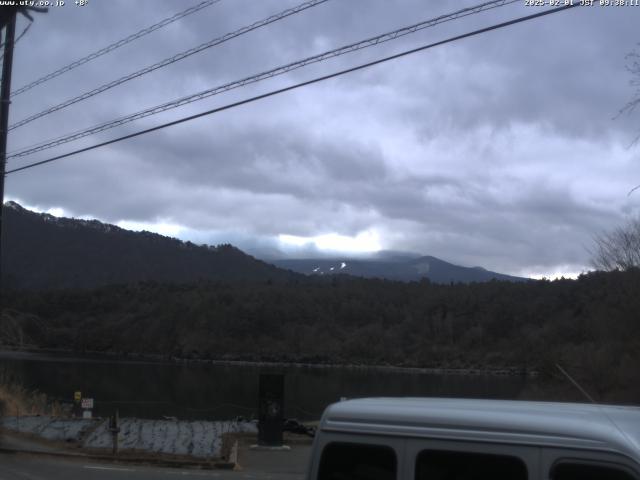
(0, 269, 640, 402)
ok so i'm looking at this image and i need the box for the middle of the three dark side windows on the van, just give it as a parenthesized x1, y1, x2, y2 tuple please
(416, 450, 527, 480)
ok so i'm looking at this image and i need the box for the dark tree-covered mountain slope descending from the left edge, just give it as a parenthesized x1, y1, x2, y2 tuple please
(2, 202, 297, 289)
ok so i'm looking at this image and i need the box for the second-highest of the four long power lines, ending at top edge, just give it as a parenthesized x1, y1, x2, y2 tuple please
(9, 0, 329, 130)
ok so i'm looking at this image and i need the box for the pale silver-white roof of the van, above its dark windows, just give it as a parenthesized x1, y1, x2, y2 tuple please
(319, 398, 640, 462)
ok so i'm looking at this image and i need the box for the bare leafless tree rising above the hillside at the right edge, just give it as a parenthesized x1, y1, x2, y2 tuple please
(591, 217, 640, 271)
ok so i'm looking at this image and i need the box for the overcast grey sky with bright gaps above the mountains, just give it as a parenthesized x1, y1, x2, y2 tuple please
(6, 0, 640, 276)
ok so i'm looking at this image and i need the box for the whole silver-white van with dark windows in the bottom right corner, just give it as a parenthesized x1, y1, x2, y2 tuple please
(308, 398, 640, 480)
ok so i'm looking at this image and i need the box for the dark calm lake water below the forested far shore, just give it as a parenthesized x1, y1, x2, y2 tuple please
(0, 352, 537, 420)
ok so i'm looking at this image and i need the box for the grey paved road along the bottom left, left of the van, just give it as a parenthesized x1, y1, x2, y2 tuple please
(0, 454, 304, 480)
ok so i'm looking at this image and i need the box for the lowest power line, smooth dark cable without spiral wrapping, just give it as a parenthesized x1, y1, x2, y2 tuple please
(7, 3, 579, 174)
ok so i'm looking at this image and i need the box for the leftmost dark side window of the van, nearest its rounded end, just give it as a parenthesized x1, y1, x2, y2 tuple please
(318, 443, 397, 480)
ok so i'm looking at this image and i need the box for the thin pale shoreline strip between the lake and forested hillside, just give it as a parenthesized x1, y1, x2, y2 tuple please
(0, 345, 540, 377)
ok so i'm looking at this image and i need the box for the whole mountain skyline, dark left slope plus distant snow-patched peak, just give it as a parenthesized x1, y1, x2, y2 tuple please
(2, 202, 526, 289)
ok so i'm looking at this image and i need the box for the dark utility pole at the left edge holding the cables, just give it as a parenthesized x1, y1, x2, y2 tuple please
(0, 9, 18, 298)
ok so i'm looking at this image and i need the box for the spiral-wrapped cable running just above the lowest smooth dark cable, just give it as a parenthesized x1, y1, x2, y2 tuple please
(7, 0, 520, 158)
